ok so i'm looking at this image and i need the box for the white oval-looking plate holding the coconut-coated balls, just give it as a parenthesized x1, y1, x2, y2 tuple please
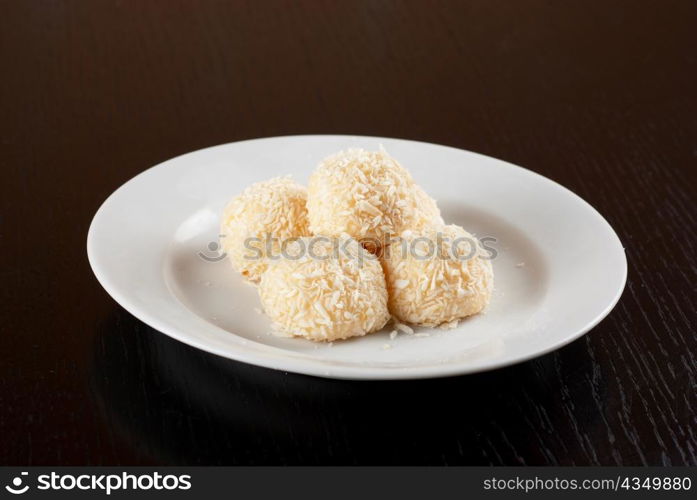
(87, 136, 627, 379)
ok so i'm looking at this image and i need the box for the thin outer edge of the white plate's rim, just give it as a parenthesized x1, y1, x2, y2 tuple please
(86, 134, 628, 380)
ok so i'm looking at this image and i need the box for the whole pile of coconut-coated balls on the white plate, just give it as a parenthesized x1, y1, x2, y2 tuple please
(221, 145, 494, 341)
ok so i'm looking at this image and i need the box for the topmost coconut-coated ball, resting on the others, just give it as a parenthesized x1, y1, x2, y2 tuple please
(307, 149, 424, 246)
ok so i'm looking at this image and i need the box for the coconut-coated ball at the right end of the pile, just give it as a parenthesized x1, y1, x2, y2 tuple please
(382, 225, 494, 326)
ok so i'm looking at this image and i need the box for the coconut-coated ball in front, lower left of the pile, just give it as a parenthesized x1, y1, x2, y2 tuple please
(258, 236, 390, 341)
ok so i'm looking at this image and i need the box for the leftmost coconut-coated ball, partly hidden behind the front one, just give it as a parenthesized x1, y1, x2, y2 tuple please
(220, 177, 310, 282)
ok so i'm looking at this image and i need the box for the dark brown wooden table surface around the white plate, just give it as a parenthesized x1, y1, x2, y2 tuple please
(0, 0, 697, 465)
